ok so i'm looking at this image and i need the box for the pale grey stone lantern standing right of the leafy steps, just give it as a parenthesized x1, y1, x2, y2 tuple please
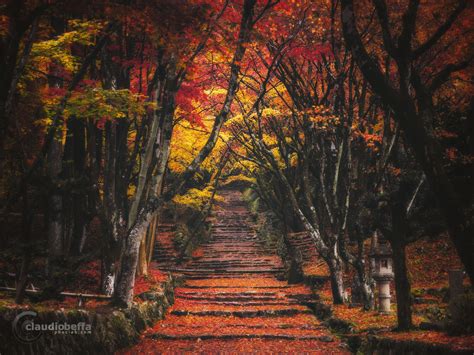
(369, 240, 394, 314)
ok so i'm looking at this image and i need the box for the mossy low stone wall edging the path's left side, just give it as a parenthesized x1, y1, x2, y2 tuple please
(0, 275, 182, 355)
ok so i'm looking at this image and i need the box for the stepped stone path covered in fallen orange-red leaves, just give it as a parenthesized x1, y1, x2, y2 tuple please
(121, 191, 346, 354)
